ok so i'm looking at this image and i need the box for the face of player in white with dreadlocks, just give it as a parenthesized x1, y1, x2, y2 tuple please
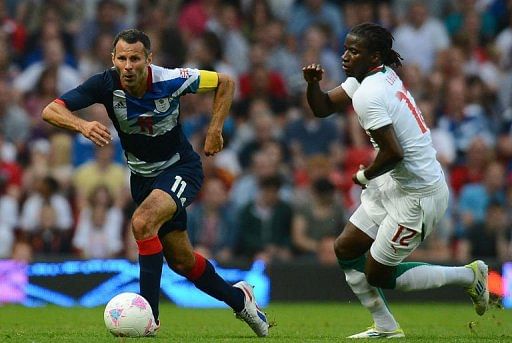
(341, 34, 379, 81)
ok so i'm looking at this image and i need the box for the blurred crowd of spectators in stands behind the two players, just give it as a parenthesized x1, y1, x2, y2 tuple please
(0, 0, 512, 264)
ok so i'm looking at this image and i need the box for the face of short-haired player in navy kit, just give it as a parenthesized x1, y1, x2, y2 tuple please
(112, 40, 151, 89)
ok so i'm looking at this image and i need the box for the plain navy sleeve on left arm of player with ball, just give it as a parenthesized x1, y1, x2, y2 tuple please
(59, 71, 112, 111)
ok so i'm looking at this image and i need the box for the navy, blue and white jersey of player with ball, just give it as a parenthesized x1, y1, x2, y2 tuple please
(60, 65, 200, 176)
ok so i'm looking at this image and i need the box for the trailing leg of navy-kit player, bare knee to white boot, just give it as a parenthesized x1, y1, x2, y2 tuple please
(162, 230, 269, 336)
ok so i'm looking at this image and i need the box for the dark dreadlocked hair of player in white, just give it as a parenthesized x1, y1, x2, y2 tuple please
(350, 23, 403, 67)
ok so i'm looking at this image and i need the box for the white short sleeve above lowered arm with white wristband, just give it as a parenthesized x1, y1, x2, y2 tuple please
(352, 86, 392, 130)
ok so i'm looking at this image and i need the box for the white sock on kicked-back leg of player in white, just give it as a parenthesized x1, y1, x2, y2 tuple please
(395, 264, 475, 291)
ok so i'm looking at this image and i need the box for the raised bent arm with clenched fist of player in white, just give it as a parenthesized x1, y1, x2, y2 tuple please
(302, 64, 351, 118)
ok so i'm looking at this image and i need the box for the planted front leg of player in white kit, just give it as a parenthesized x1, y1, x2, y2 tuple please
(334, 207, 403, 338)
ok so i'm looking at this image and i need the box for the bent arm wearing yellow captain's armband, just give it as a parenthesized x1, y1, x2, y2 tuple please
(198, 70, 235, 156)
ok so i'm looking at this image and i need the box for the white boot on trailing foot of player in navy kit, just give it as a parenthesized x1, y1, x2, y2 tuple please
(233, 281, 270, 337)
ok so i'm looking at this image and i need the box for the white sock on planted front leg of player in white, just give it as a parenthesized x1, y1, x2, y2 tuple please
(343, 269, 398, 331)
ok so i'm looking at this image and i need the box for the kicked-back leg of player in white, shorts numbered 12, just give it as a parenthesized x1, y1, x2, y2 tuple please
(366, 190, 489, 315)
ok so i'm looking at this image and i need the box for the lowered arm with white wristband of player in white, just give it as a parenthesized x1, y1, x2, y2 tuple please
(353, 124, 404, 185)
